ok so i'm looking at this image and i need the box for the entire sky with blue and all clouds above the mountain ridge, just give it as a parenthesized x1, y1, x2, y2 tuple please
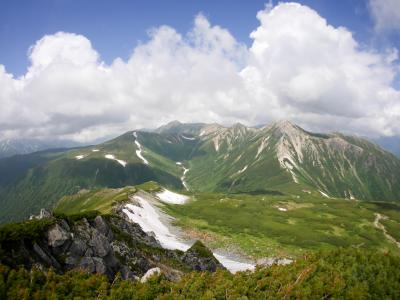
(0, 0, 400, 142)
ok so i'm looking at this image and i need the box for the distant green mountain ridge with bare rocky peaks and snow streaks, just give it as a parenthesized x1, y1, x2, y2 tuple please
(0, 121, 400, 220)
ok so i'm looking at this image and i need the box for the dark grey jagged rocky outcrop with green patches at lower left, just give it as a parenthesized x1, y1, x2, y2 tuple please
(0, 215, 223, 280)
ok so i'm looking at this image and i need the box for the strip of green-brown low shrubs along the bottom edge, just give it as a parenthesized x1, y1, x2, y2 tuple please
(0, 248, 400, 299)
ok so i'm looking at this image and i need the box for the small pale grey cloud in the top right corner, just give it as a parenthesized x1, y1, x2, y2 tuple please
(369, 0, 400, 31)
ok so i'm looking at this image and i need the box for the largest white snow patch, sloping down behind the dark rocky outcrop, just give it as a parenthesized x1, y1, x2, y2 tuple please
(122, 195, 190, 251)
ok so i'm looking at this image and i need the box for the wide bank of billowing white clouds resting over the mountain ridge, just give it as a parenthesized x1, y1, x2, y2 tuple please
(0, 3, 400, 141)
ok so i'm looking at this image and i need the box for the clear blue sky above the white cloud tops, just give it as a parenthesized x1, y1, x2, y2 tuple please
(0, 0, 394, 76)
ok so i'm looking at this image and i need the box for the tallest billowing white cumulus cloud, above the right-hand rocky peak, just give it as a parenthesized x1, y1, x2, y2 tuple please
(242, 3, 400, 134)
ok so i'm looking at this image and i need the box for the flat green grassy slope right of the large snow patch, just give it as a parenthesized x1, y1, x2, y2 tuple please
(164, 192, 400, 257)
